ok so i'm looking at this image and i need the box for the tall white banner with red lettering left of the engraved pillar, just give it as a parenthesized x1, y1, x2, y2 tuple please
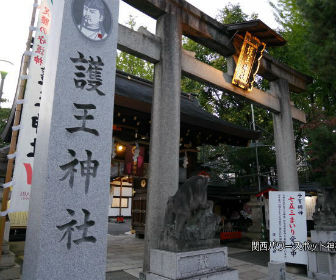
(9, 0, 52, 213)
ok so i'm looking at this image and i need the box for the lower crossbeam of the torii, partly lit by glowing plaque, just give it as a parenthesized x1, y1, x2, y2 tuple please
(118, 24, 306, 123)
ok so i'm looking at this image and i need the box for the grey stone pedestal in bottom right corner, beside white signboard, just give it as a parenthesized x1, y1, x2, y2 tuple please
(308, 230, 336, 280)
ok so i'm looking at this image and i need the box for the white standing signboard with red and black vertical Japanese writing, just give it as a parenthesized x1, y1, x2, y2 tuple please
(269, 192, 307, 264)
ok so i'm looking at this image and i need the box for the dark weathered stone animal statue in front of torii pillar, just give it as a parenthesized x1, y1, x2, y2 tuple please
(160, 176, 220, 251)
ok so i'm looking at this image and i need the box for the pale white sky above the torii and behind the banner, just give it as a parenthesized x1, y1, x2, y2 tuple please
(0, 0, 278, 107)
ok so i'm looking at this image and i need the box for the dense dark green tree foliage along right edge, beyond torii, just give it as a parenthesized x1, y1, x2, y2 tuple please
(271, 0, 336, 186)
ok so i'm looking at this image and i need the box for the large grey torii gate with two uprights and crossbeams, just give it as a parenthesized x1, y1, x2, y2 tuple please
(118, 0, 309, 272)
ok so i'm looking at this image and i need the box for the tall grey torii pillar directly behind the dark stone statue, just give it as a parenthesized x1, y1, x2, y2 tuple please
(144, 11, 182, 272)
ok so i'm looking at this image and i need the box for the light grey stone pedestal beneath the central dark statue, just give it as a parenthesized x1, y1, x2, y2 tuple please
(146, 247, 238, 280)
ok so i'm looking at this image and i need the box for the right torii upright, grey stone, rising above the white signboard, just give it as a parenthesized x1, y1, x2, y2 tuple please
(271, 79, 299, 191)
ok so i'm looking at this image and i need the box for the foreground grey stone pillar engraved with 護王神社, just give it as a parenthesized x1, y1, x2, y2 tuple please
(22, 0, 119, 280)
